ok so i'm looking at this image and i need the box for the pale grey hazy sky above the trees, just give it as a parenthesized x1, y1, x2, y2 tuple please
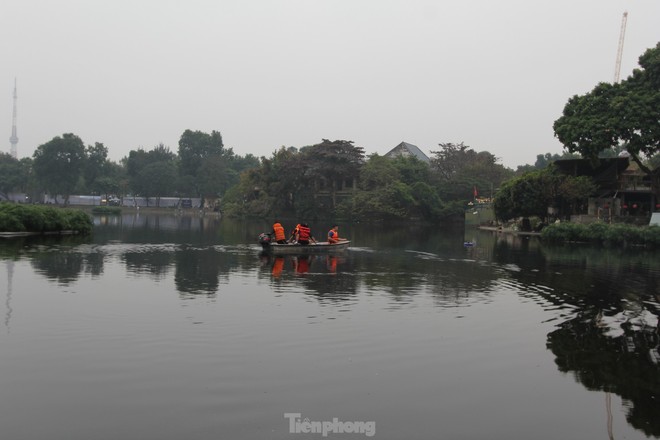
(0, 0, 660, 168)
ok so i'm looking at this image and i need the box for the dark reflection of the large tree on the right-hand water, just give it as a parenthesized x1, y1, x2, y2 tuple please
(480, 230, 660, 437)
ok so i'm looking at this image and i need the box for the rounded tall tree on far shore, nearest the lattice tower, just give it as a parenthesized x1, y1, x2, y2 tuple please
(33, 133, 85, 205)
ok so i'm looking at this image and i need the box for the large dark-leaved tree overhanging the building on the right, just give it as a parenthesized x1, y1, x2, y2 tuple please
(553, 43, 660, 194)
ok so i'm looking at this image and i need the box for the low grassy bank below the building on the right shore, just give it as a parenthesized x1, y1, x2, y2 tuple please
(541, 222, 660, 248)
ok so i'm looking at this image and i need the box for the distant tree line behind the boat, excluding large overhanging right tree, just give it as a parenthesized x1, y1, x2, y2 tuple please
(0, 130, 628, 222)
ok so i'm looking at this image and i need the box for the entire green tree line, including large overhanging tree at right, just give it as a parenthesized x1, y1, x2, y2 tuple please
(0, 43, 660, 221)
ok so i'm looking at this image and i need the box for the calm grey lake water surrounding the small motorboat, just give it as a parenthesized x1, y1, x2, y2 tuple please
(0, 214, 660, 440)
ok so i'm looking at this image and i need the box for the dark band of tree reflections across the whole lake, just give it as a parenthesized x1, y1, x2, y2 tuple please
(0, 214, 660, 436)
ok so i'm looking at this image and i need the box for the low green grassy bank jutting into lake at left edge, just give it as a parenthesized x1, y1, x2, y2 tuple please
(0, 203, 94, 234)
